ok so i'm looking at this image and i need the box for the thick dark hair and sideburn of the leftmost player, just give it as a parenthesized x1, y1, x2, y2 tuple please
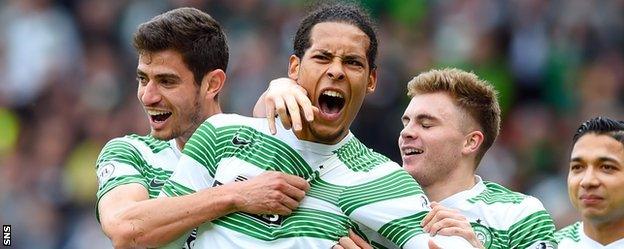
(133, 7, 229, 85)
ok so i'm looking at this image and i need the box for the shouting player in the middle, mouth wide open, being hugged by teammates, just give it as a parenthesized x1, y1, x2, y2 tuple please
(163, 5, 470, 248)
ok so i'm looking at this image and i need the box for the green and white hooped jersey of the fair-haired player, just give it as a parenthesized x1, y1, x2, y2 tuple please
(440, 176, 557, 249)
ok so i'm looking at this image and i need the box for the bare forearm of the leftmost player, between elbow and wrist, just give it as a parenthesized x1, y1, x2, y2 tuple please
(103, 186, 236, 248)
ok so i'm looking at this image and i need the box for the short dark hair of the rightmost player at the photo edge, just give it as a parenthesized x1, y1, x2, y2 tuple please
(572, 117, 624, 145)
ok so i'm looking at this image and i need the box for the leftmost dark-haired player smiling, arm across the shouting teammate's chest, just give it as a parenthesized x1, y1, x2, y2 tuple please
(97, 8, 308, 248)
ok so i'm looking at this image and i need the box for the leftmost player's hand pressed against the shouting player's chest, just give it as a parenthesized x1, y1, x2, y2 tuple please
(226, 171, 310, 215)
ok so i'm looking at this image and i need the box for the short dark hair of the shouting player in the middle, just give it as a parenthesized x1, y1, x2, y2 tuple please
(293, 3, 377, 70)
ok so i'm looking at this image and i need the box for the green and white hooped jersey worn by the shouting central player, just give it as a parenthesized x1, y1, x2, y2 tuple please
(163, 114, 468, 249)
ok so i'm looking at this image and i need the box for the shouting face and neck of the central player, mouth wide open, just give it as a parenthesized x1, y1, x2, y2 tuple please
(289, 22, 377, 144)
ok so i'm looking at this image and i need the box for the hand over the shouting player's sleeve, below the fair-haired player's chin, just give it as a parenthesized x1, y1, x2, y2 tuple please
(421, 202, 483, 248)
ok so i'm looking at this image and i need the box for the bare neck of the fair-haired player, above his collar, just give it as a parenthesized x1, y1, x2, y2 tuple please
(422, 162, 477, 202)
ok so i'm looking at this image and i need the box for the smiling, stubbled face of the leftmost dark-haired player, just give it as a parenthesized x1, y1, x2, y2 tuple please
(137, 50, 202, 140)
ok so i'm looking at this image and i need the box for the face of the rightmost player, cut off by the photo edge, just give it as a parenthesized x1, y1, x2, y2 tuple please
(568, 134, 624, 224)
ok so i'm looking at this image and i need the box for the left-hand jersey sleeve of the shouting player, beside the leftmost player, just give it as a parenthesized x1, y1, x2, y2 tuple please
(161, 121, 221, 196)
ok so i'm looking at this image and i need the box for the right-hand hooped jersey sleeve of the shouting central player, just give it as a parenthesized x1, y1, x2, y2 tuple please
(339, 166, 471, 248)
